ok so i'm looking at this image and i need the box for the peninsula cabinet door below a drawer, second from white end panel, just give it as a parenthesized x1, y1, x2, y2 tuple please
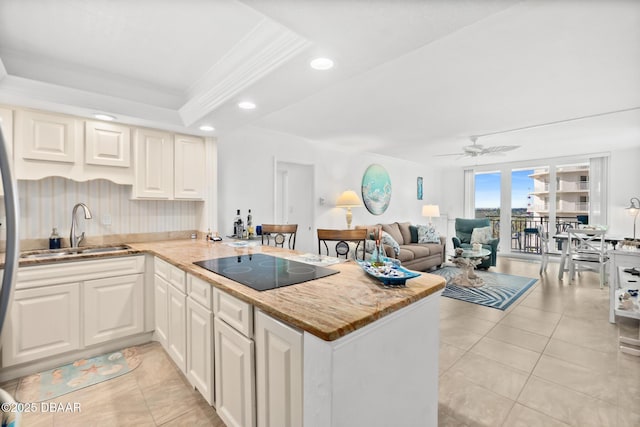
(213, 317, 255, 427)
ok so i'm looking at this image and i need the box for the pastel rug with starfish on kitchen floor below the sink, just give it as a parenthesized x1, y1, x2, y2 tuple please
(15, 347, 141, 402)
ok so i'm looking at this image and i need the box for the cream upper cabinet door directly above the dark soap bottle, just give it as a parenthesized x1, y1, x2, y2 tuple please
(18, 111, 78, 163)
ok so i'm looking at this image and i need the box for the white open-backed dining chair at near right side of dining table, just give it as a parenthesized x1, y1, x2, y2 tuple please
(567, 228, 609, 288)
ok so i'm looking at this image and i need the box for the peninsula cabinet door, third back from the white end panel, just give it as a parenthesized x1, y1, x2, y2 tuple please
(187, 297, 214, 405)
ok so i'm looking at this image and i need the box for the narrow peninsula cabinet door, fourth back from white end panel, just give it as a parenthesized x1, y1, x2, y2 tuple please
(167, 286, 187, 373)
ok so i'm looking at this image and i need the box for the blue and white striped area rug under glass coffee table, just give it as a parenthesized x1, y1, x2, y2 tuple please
(430, 267, 538, 310)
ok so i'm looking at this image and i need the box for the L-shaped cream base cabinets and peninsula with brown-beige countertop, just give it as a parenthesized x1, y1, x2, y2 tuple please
(0, 239, 444, 427)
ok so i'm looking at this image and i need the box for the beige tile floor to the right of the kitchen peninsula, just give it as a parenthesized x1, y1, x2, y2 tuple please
(439, 258, 640, 427)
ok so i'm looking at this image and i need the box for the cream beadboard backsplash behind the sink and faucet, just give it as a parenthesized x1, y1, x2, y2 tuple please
(0, 177, 200, 244)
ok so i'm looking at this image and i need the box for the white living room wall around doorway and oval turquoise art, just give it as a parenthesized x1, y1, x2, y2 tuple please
(218, 128, 443, 251)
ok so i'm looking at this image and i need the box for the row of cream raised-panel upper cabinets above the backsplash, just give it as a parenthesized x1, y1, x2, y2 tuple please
(7, 106, 207, 200)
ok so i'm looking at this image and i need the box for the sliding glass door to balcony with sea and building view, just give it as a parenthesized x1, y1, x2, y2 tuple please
(466, 157, 608, 254)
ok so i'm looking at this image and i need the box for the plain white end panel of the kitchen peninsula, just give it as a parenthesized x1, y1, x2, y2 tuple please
(303, 290, 442, 427)
